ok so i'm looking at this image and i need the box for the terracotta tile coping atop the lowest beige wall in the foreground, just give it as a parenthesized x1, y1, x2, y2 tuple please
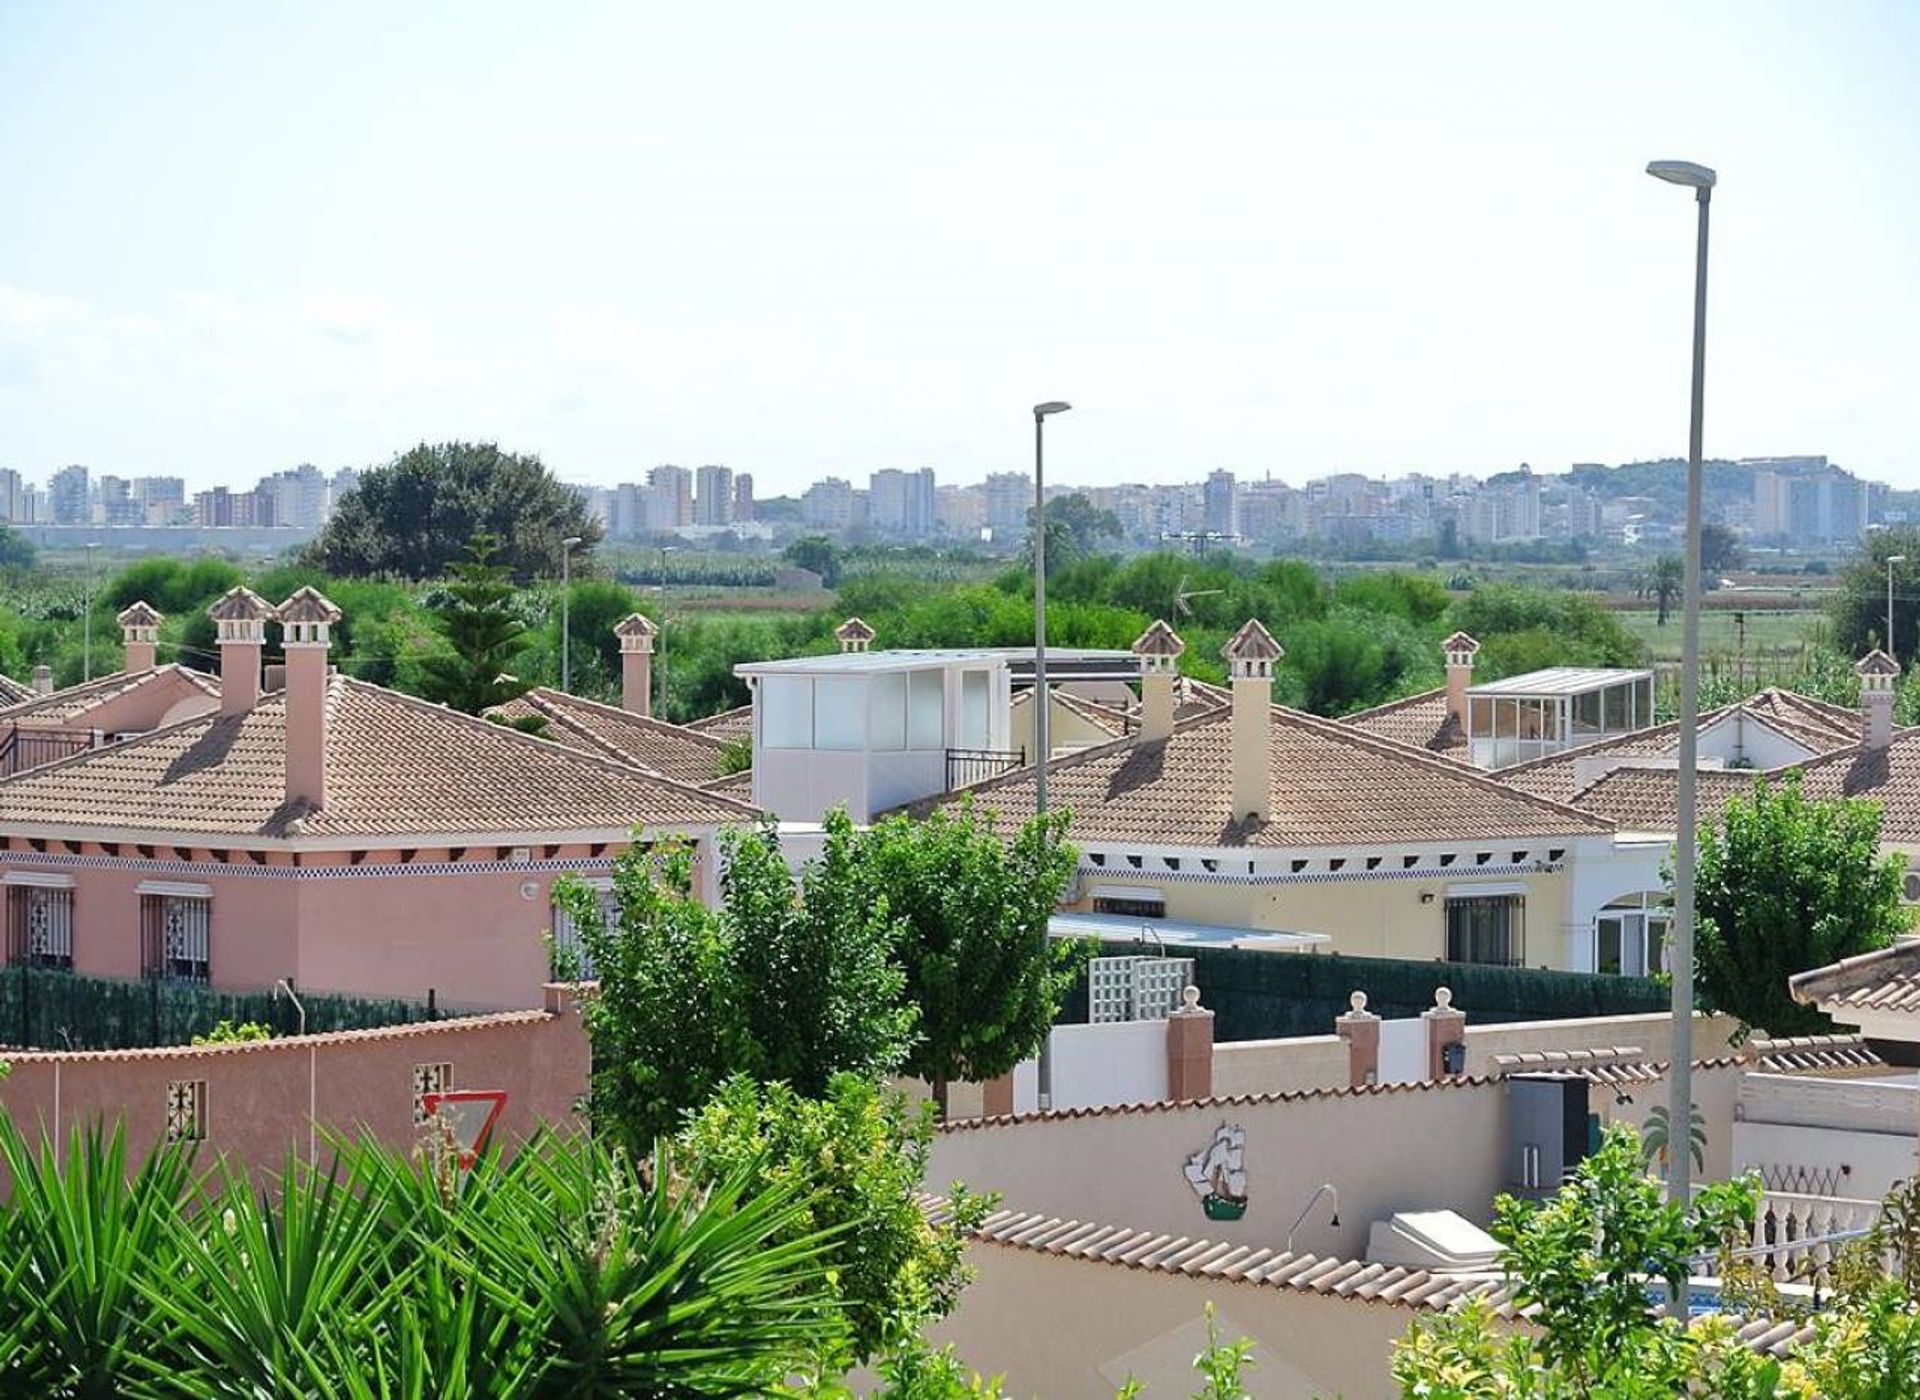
(924, 1198, 1812, 1356)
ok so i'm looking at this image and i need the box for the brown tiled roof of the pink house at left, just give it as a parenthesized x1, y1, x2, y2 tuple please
(0, 676, 758, 837)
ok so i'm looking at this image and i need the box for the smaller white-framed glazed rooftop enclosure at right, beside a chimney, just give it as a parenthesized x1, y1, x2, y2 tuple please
(1467, 666, 1653, 768)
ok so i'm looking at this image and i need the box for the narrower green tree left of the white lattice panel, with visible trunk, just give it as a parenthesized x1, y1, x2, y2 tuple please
(860, 805, 1087, 1112)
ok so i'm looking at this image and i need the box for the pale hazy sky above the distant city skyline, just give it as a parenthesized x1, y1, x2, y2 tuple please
(0, 0, 1920, 495)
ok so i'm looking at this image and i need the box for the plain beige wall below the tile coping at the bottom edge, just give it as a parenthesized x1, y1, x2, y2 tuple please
(929, 1243, 1474, 1400)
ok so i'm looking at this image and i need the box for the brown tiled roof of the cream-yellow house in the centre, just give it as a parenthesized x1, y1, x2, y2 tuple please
(916, 705, 1609, 847)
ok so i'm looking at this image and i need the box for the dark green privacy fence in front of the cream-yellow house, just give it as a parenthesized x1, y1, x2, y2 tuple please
(1062, 941, 1668, 1041)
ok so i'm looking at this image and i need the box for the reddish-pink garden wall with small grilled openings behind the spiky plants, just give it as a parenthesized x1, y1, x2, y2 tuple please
(0, 1001, 589, 1171)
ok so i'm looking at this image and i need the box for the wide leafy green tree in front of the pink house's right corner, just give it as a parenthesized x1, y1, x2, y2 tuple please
(555, 810, 914, 1150)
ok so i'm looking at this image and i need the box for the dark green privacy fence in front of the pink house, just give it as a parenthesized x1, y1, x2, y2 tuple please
(0, 964, 455, 1050)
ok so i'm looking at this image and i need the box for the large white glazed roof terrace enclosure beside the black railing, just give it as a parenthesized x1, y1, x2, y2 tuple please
(733, 638, 1140, 822)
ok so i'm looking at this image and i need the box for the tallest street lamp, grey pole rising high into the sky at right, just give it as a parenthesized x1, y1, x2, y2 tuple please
(1647, 161, 1716, 1221)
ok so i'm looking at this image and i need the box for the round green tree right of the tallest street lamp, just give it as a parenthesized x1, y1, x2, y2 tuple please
(1693, 774, 1910, 1035)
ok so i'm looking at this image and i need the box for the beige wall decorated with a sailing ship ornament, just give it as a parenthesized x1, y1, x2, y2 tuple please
(927, 1083, 1507, 1258)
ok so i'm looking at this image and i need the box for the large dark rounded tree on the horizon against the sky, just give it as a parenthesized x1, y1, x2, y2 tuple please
(305, 442, 601, 578)
